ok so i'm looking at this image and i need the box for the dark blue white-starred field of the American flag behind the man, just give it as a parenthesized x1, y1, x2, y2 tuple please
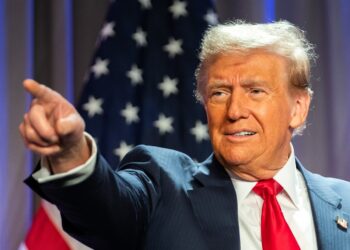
(78, 0, 218, 166)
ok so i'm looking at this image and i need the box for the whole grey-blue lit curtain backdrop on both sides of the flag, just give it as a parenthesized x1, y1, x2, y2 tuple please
(0, 0, 350, 249)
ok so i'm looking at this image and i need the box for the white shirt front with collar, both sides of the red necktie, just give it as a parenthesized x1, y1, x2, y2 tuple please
(231, 145, 317, 250)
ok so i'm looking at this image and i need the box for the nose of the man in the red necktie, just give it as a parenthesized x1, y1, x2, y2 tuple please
(227, 91, 249, 121)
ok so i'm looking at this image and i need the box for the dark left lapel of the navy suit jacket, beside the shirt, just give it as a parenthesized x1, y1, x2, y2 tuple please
(188, 156, 240, 250)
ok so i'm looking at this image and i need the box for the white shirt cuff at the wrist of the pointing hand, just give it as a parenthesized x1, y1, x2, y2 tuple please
(32, 132, 97, 186)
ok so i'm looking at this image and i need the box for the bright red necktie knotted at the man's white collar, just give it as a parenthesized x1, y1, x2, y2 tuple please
(253, 179, 300, 250)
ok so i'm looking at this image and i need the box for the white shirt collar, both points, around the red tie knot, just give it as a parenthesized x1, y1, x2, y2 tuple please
(230, 144, 300, 207)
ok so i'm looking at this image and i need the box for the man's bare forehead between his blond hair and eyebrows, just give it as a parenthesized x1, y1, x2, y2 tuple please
(207, 51, 288, 83)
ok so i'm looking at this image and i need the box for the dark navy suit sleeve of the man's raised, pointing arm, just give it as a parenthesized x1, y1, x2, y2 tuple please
(25, 147, 160, 249)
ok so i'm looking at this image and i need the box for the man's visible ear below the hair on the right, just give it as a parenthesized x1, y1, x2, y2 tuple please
(289, 91, 311, 129)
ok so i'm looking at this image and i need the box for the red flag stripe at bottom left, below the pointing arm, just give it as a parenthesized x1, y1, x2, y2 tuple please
(25, 206, 70, 250)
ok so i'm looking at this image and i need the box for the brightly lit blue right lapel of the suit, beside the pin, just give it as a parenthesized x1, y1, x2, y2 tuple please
(297, 160, 350, 250)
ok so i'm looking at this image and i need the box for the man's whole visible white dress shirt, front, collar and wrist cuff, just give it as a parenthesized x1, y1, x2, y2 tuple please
(33, 138, 317, 250)
